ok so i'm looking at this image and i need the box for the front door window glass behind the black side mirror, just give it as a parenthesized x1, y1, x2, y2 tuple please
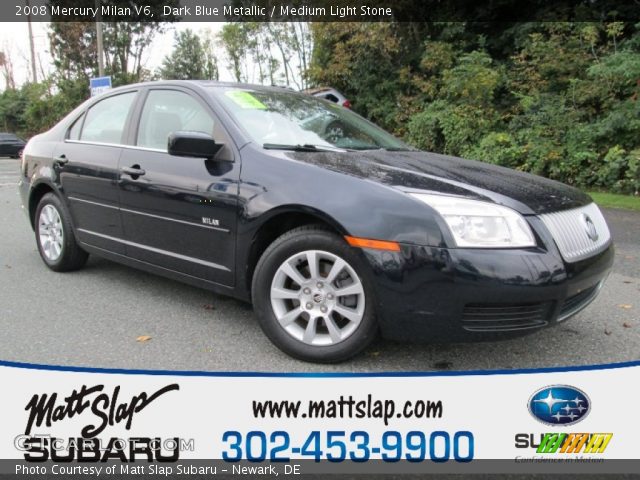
(137, 90, 214, 150)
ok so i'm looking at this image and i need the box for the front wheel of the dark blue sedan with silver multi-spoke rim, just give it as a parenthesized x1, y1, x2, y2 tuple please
(252, 226, 378, 363)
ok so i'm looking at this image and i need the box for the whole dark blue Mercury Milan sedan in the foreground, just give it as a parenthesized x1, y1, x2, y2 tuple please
(19, 81, 613, 362)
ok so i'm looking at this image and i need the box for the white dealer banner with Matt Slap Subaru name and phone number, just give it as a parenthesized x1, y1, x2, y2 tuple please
(0, 362, 640, 472)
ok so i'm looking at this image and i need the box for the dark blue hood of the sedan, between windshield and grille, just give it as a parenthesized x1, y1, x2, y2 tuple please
(287, 150, 591, 215)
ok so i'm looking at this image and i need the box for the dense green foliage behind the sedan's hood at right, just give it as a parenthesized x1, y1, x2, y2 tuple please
(310, 22, 640, 193)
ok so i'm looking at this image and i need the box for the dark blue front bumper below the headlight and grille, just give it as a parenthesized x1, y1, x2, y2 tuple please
(364, 236, 614, 342)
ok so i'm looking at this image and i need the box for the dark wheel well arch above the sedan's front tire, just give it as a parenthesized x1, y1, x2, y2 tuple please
(246, 212, 344, 292)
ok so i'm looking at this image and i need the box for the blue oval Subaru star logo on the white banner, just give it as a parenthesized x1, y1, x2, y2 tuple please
(529, 385, 591, 425)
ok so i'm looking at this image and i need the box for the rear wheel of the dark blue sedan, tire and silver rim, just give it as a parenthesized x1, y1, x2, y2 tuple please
(35, 193, 89, 272)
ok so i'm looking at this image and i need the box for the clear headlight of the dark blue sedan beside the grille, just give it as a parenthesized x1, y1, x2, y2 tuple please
(410, 193, 536, 248)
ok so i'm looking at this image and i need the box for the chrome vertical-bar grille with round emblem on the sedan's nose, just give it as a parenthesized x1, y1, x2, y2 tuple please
(540, 203, 611, 262)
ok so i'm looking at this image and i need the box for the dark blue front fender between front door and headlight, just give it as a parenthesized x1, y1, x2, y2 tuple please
(239, 146, 446, 247)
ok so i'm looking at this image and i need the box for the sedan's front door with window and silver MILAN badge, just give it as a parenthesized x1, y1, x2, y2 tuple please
(119, 87, 240, 285)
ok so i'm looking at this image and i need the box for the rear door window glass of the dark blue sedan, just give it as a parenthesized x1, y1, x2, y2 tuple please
(79, 92, 136, 144)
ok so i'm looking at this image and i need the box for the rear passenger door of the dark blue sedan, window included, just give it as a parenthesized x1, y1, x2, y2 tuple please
(59, 91, 137, 254)
